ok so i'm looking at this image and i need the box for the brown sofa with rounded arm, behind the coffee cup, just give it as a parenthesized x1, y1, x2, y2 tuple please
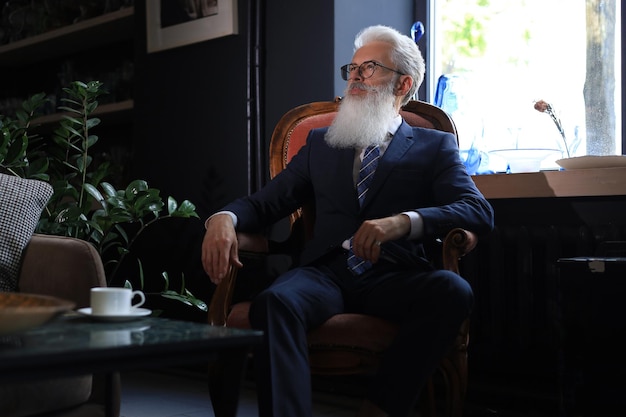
(0, 234, 120, 417)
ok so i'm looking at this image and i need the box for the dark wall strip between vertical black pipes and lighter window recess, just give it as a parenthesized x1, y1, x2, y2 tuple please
(262, 0, 335, 185)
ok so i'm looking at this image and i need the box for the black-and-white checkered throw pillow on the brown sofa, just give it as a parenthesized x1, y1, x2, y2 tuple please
(0, 174, 52, 291)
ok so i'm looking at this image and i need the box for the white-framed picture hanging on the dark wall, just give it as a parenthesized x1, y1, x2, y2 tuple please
(146, 0, 237, 53)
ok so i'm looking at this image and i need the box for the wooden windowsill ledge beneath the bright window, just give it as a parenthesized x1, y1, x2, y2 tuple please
(472, 168, 626, 199)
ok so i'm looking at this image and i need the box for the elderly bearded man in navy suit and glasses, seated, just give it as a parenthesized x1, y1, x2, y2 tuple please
(202, 26, 493, 417)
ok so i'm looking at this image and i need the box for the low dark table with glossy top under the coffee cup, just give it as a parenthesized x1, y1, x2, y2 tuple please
(0, 313, 262, 417)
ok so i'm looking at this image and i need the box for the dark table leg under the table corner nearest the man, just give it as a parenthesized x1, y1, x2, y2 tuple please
(209, 349, 249, 417)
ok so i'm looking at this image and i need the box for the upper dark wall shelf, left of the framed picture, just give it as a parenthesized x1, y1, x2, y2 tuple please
(0, 7, 135, 67)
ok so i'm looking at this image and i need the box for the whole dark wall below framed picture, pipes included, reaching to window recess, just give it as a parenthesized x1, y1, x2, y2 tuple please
(133, 0, 333, 217)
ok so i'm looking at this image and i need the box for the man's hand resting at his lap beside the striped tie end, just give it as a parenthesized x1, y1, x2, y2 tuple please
(352, 214, 411, 263)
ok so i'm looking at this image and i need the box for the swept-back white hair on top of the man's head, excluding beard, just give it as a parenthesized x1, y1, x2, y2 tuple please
(354, 25, 426, 105)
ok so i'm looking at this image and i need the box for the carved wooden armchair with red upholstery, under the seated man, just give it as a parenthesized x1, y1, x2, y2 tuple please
(209, 101, 477, 417)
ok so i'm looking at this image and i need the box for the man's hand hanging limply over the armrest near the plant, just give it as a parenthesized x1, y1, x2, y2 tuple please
(202, 214, 243, 285)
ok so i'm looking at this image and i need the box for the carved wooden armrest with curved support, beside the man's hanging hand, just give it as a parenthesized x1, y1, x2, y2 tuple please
(209, 233, 269, 326)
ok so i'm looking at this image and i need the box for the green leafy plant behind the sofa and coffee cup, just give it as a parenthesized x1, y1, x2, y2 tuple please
(0, 81, 207, 311)
